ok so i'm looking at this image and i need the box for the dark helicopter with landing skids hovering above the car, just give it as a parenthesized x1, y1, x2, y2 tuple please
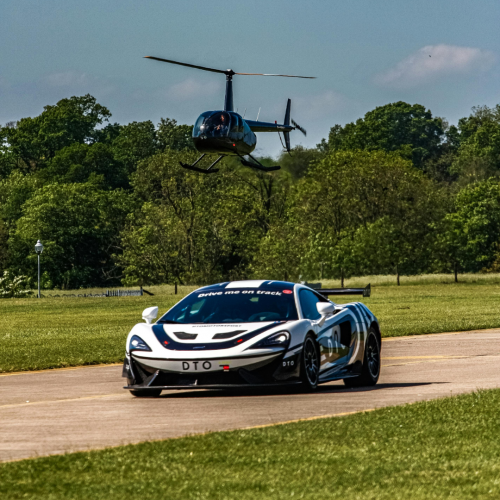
(145, 56, 316, 174)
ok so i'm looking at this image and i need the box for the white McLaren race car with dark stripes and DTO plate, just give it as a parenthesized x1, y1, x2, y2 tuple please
(123, 281, 381, 397)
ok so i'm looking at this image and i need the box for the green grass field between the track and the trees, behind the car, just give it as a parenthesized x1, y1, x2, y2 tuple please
(0, 274, 500, 372)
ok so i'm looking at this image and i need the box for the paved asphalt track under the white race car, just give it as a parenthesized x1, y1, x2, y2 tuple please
(0, 329, 500, 461)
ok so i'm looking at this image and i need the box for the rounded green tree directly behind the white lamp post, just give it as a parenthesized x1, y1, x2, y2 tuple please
(9, 184, 130, 288)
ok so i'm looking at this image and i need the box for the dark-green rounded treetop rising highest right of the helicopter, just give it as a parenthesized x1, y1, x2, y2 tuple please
(328, 101, 444, 170)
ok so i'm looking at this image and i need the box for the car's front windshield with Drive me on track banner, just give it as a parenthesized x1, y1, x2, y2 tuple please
(158, 288, 298, 324)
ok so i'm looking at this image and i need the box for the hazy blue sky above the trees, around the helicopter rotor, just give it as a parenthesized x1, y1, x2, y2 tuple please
(0, 0, 500, 155)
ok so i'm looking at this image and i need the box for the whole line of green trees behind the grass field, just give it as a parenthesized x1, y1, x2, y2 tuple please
(0, 95, 500, 288)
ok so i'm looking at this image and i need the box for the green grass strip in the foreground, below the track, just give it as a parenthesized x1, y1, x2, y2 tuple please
(0, 390, 500, 500)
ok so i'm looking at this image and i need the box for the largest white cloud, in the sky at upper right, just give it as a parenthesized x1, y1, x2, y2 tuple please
(375, 44, 496, 87)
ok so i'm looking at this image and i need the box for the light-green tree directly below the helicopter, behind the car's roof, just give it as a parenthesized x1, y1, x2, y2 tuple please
(121, 149, 292, 284)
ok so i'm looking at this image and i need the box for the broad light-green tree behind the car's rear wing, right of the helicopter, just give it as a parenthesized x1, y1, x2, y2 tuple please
(255, 151, 442, 279)
